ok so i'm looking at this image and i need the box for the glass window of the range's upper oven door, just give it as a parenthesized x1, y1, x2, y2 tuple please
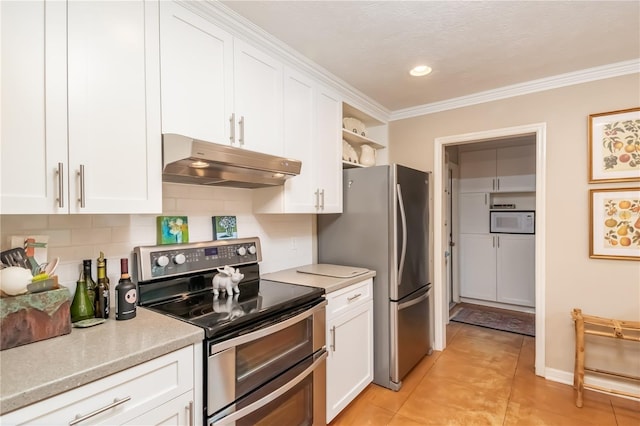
(236, 318, 313, 397)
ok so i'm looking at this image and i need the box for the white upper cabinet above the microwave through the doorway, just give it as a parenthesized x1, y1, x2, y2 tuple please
(460, 144, 536, 192)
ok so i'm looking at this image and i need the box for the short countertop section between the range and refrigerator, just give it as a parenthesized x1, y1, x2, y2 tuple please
(261, 264, 376, 293)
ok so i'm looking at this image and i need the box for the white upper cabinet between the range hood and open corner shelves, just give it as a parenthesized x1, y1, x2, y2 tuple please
(254, 68, 342, 213)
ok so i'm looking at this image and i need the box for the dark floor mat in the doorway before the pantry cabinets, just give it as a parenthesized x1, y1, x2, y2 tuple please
(451, 304, 536, 337)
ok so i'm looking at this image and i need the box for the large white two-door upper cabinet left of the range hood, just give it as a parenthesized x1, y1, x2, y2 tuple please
(0, 0, 162, 214)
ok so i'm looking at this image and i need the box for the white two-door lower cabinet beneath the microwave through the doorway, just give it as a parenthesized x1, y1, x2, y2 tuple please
(460, 234, 535, 307)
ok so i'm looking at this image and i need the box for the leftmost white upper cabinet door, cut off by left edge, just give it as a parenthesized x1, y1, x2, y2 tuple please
(0, 1, 69, 214)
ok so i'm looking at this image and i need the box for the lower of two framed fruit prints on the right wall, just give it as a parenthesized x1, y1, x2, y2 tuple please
(589, 188, 640, 260)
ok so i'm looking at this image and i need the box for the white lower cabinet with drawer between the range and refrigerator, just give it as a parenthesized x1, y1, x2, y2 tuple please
(327, 278, 373, 423)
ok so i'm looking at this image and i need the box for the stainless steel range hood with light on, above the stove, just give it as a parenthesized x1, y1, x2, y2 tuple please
(162, 133, 302, 188)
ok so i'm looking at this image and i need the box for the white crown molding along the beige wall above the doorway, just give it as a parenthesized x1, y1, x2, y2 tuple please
(390, 58, 640, 121)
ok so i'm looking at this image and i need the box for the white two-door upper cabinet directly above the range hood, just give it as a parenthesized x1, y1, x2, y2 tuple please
(160, 1, 284, 155)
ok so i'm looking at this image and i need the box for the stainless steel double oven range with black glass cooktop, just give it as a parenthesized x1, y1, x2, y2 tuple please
(134, 238, 327, 426)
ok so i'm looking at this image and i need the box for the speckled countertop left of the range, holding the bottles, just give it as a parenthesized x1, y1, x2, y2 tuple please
(0, 307, 204, 413)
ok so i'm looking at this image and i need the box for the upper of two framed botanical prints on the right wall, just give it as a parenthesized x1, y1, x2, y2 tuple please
(589, 108, 640, 183)
